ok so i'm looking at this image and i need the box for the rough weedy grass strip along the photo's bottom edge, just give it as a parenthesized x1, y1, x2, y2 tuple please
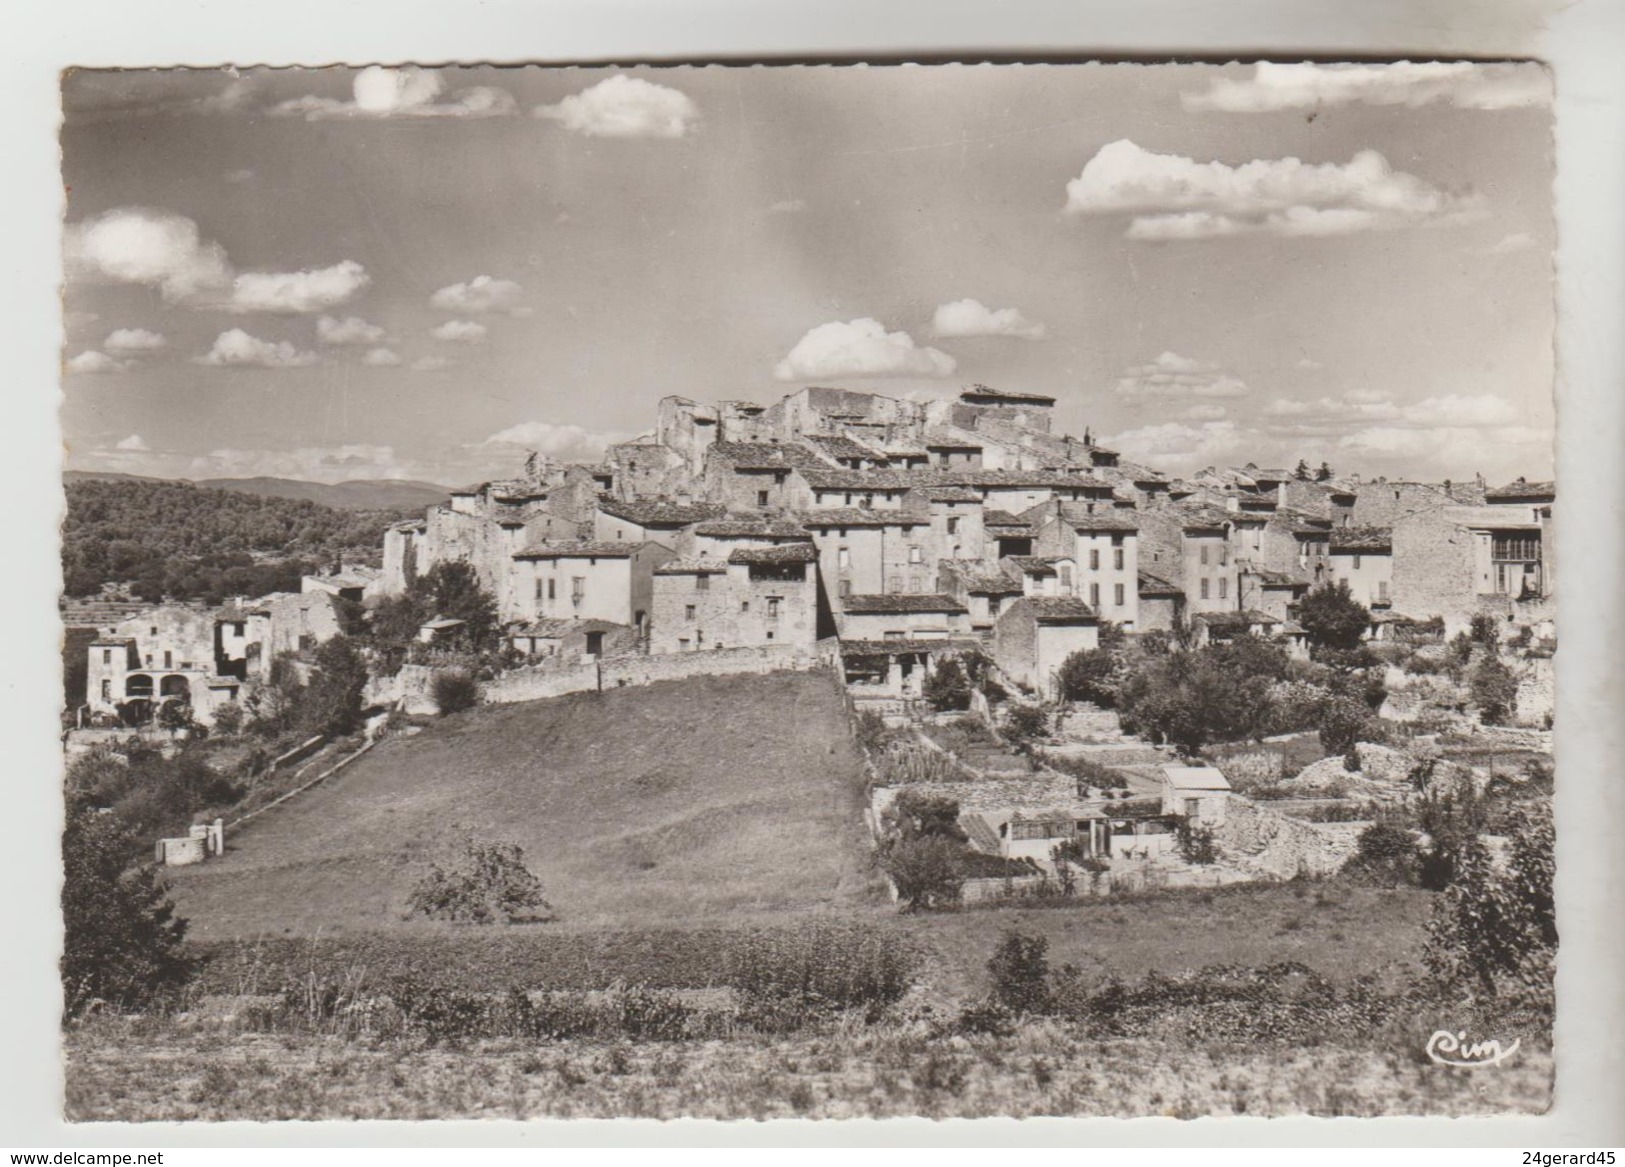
(67, 1021, 1552, 1121)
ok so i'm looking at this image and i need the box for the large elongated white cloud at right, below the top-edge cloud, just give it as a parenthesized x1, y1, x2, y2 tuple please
(1066, 138, 1484, 241)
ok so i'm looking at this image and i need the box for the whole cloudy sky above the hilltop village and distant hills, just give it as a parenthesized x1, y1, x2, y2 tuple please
(62, 65, 1554, 483)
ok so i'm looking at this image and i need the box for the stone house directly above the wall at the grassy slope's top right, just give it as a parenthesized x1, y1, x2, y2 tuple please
(648, 541, 819, 653)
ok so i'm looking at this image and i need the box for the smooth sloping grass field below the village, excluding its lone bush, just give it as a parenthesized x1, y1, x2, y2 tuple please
(171, 673, 876, 939)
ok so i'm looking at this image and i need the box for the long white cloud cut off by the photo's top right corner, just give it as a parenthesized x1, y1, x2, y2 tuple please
(1180, 60, 1552, 114)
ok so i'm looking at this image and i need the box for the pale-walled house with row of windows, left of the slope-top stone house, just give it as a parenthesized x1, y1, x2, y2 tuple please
(512, 540, 674, 637)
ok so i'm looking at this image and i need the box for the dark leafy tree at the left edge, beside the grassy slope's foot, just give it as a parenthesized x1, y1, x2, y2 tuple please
(60, 811, 192, 1017)
